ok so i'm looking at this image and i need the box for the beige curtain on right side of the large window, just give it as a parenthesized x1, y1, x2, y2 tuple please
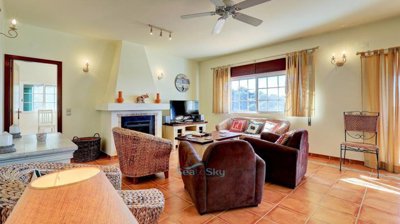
(285, 50, 315, 117)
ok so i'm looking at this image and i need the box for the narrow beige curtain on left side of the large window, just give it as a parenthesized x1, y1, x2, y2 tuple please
(213, 67, 230, 114)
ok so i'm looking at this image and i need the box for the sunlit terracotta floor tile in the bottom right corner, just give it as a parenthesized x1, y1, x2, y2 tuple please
(359, 206, 400, 224)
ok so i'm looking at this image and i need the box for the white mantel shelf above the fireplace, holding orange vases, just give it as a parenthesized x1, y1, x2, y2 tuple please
(96, 103, 169, 111)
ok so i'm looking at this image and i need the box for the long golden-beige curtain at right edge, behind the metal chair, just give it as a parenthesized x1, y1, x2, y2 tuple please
(361, 48, 400, 173)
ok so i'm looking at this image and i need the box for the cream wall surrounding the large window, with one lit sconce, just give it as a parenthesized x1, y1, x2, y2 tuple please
(199, 17, 400, 160)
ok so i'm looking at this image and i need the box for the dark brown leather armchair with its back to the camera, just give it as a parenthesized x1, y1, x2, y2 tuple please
(179, 140, 265, 214)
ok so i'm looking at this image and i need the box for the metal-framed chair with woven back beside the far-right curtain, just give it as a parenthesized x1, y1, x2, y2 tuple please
(340, 111, 379, 178)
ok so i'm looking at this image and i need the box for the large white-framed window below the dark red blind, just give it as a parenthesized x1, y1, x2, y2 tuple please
(231, 71, 286, 113)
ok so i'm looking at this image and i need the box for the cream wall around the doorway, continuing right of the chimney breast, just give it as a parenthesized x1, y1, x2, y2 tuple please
(0, 21, 198, 138)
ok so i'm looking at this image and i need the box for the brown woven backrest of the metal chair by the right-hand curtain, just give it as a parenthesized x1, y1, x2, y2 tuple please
(343, 111, 379, 142)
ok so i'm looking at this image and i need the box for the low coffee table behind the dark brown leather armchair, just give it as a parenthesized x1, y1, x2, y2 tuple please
(175, 131, 242, 157)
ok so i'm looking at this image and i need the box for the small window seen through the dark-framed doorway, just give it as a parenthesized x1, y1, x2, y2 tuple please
(23, 84, 57, 111)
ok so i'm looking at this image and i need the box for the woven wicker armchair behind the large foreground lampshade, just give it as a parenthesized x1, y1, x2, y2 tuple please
(0, 163, 164, 224)
